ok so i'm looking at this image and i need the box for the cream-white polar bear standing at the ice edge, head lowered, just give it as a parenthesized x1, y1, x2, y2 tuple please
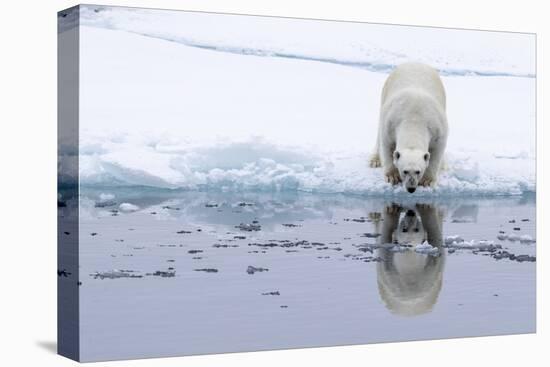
(370, 63, 448, 193)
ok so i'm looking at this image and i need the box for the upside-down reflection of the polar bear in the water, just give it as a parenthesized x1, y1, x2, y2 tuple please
(371, 204, 445, 316)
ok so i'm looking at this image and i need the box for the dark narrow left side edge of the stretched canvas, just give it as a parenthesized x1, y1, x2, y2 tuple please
(57, 6, 80, 361)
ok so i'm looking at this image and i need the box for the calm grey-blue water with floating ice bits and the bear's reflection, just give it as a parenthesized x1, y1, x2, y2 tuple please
(75, 188, 536, 360)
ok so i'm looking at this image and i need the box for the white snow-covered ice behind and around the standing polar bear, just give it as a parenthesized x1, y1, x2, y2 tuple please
(67, 7, 535, 196)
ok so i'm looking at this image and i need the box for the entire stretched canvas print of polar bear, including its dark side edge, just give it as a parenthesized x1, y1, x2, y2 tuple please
(57, 5, 536, 361)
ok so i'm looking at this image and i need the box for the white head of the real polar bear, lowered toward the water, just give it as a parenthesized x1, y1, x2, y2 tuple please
(393, 149, 430, 193)
